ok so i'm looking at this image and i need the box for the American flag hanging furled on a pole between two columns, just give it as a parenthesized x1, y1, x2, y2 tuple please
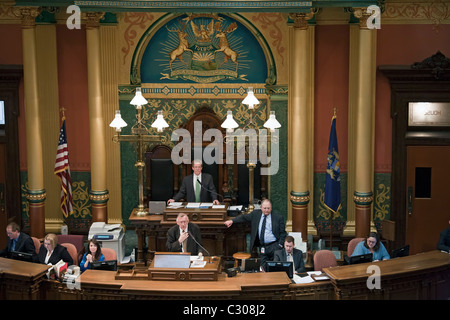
(54, 119, 73, 218)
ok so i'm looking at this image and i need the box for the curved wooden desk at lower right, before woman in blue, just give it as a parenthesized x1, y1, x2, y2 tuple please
(324, 250, 450, 300)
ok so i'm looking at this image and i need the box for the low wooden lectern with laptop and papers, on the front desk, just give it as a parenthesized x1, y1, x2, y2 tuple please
(115, 252, 221, 281)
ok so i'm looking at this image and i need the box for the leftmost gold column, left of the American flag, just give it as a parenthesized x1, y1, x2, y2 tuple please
(14, 7, 46, 238)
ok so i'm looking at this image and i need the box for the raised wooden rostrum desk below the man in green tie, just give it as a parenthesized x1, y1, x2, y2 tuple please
(129, 209, 250, 263)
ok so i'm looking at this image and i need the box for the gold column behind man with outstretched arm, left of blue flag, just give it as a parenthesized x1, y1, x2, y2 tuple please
(288, 13, 314, 241)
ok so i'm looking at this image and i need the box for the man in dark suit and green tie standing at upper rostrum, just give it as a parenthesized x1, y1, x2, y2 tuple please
(167, 160, 220, 204)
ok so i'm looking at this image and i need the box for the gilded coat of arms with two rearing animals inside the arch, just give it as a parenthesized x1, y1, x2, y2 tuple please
(161, 14, 247, 83)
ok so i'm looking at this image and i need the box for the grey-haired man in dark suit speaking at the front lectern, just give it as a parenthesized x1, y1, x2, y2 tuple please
(166, 213, 202, 255)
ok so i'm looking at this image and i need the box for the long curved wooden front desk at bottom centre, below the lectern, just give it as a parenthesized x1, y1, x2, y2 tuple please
(80, 270, 291, 300)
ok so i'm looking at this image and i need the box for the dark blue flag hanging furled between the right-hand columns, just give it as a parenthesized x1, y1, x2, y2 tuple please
(324, 113, 341, 213)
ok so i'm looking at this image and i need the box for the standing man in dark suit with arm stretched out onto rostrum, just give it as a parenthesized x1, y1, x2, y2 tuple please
(225, 199, 286, 270)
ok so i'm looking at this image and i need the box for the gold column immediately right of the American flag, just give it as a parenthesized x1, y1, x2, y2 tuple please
(86, 12, 109, 222)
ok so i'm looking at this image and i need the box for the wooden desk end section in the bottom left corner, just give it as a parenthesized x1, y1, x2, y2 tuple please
(0, 258, 48, 300)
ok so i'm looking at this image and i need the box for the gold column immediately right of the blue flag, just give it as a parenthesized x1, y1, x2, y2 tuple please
(353, 8, 376, 238)
